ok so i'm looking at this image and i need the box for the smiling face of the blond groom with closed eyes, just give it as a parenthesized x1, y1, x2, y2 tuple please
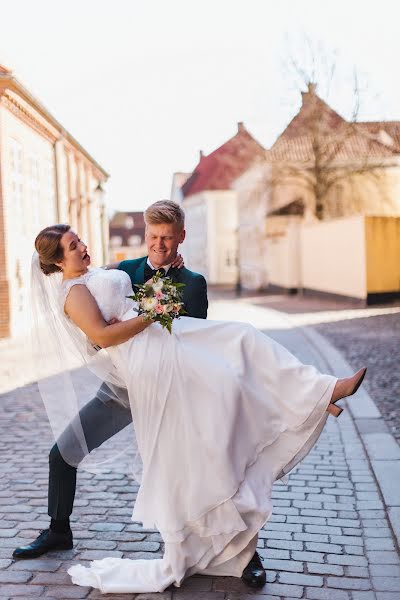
(146, 223, 185, 267)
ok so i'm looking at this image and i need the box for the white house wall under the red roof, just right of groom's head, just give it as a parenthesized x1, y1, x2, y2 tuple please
(182, 190, 238, 285)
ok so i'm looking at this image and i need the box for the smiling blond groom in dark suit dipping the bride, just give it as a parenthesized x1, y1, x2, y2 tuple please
(13, 200, 265, 587)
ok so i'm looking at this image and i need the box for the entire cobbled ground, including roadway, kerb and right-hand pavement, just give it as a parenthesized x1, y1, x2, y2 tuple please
(0, 297, 400, 600)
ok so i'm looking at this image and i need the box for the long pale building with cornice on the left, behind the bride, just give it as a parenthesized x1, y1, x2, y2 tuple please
(0, 65, 108, 337)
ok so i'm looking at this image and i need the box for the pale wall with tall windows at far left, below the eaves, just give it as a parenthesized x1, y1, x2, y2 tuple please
(0, 105, 57, 334)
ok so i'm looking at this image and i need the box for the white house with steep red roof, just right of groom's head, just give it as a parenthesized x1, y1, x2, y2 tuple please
(175, 123, 265, 284)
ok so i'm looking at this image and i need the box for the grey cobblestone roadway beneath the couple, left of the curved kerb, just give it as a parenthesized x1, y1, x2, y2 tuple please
(0, 302, 400, 600)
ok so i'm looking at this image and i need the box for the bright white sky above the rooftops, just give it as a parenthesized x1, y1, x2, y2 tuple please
(0, 0, 400, 213)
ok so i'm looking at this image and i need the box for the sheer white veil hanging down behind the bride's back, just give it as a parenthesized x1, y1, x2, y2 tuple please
(30, 251, 142, 482)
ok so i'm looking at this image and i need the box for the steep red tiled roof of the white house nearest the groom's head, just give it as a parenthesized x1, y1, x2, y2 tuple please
(182, 124, 265, 197)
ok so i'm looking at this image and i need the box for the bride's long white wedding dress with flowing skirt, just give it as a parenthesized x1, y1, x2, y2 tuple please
(62, 269, 336, 593)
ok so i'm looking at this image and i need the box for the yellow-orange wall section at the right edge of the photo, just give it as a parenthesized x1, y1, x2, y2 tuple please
(365, 217, 400, 294)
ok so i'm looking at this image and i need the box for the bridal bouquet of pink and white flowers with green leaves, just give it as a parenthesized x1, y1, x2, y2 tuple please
(128, 271, 186, 333)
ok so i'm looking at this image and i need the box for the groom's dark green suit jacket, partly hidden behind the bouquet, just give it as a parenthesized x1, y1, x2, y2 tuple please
(118, 256, 208, 319)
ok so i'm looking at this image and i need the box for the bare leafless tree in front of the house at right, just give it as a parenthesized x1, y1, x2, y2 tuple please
(268, 37, 396, 219)
